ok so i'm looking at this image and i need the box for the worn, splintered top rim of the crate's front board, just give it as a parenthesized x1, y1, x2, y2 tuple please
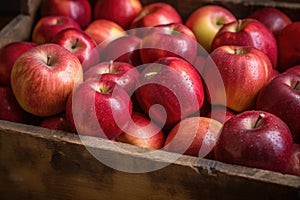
(0, 120, 300, 189)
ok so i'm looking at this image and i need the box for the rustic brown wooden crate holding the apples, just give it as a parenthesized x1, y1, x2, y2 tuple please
(0, 0, 300, 200)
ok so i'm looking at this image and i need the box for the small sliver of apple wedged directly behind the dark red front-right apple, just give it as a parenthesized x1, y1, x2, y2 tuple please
(207, 105, 237, 124)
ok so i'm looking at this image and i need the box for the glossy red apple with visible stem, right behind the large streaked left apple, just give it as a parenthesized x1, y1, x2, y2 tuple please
(51, 28, 98, 71)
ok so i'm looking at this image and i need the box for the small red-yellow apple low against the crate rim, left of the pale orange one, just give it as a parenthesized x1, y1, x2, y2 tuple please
(116, 112, 165, 149)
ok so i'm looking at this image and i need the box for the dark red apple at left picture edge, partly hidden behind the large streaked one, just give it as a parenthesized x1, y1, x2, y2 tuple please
(0, 41, 37, 86)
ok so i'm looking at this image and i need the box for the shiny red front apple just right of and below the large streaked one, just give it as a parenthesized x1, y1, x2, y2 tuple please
(72, 80, 132, 139)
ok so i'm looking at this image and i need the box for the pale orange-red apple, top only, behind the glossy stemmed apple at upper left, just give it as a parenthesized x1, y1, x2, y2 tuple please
(84, 19, 126, 44)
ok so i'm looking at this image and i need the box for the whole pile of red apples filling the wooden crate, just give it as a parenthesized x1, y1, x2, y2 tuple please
(0, 0, 300, 176)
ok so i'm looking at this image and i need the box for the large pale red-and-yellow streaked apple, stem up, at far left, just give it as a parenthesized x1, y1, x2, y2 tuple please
(11, 43, 83, 117)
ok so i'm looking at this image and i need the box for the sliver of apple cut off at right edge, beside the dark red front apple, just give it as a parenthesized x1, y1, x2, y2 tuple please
(285, 144, 300, 176)
